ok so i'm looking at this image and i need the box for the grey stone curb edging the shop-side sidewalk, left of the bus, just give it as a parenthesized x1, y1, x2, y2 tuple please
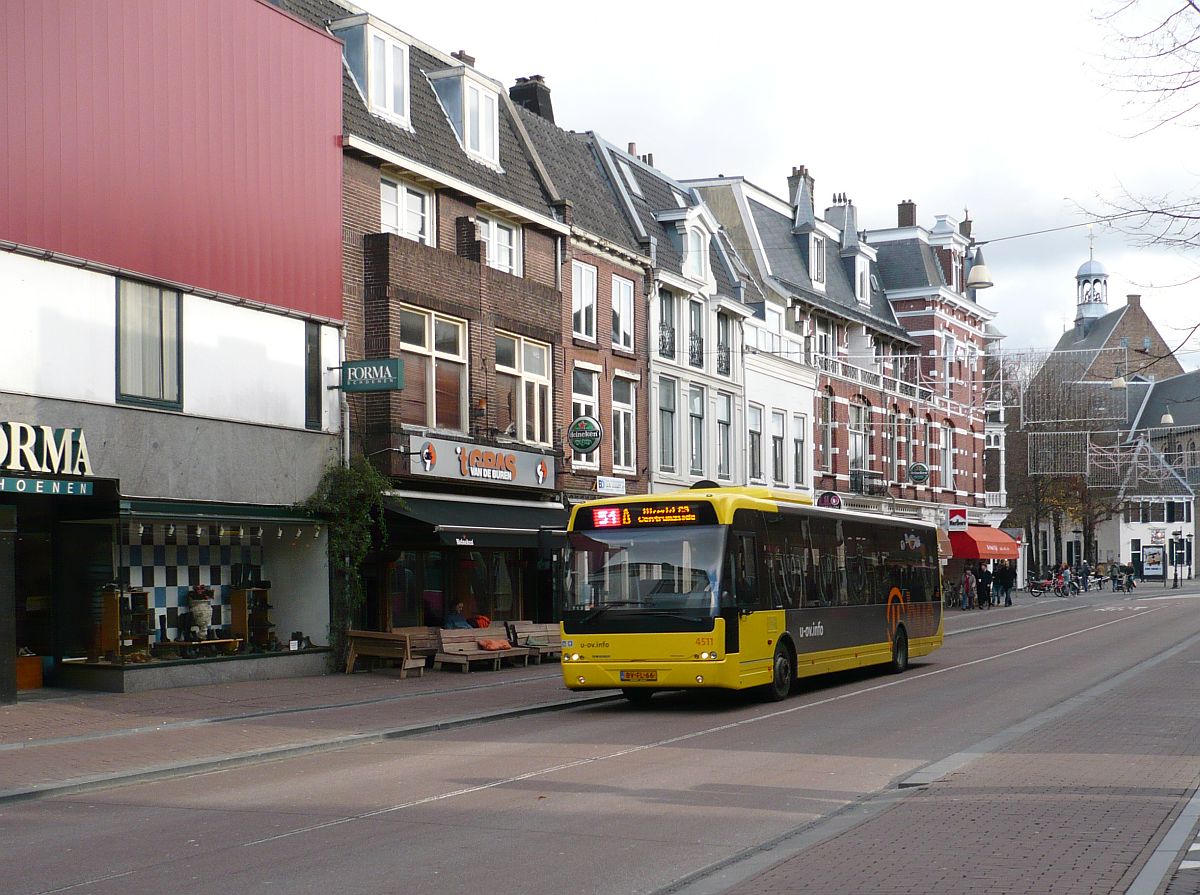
(0, 692, 622, 805)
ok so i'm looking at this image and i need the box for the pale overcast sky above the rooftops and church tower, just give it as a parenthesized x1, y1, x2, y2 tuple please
(358, 0, 1200, 368)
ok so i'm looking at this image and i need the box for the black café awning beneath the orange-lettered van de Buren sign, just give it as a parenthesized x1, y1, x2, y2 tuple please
(384, 494, 566, 547)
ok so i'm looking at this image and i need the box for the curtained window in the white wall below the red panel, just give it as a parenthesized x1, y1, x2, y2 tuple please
(116, 280, 182, 408)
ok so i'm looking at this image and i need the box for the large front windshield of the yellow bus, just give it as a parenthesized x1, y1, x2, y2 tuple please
(563, 525, 725, 619)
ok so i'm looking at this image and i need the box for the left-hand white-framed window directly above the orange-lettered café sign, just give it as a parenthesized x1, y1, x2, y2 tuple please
(400, 306, 467, 432)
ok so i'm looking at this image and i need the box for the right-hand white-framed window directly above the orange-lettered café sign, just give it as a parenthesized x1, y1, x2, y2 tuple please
(496, 330, 553, 445)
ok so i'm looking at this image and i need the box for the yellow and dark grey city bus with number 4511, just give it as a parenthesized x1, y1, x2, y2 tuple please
(560, 482, 942, 703)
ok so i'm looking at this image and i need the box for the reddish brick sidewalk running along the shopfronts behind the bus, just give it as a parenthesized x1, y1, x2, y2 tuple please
(0, 591, 1086, 804)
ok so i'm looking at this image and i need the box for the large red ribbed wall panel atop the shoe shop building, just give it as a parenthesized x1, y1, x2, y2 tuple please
(0, 0, 342, 319)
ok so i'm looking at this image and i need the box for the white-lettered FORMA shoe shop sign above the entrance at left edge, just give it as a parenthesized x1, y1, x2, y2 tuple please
(0, 421, 94, 494)
